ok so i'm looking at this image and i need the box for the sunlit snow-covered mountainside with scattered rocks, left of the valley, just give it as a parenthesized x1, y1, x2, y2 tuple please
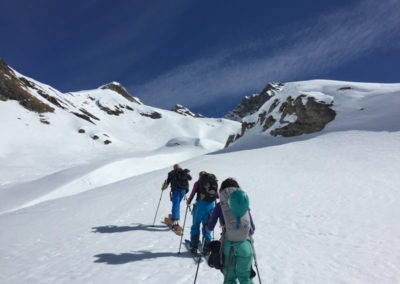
(0, 61, 240, 184)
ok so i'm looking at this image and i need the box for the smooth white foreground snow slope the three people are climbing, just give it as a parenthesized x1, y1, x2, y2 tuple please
(0, 131, 400, 283)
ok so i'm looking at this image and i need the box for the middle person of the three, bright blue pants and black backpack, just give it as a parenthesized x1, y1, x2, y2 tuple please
(187, 171, 218, 254)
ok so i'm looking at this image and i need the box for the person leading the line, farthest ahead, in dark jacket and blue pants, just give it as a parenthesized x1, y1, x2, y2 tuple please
(161, 164, 192, 231)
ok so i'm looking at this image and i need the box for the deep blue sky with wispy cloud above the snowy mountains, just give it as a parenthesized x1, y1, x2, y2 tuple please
(0, 0, 400, 117)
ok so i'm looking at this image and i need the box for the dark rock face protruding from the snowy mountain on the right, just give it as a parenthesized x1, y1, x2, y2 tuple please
(226, 84, 336, 147)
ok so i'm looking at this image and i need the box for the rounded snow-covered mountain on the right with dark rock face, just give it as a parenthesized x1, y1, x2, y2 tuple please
(226, 80, 400, 147)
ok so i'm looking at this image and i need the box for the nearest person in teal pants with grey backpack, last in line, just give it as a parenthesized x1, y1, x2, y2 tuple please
(206, 178, 255, 284)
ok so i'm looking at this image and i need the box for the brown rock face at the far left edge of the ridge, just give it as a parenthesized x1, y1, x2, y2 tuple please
(0, 60, 54, 113)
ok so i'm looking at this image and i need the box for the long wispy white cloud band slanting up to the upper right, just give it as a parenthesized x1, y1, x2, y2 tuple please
(134, 0, 400, 110)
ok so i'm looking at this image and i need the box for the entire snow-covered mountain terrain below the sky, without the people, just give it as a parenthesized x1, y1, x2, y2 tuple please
(0, 58, 400, 284)
